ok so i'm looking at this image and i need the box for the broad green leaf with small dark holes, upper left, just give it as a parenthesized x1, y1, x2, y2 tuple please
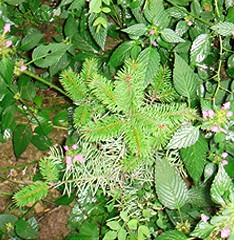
(32, 43, 70, 68)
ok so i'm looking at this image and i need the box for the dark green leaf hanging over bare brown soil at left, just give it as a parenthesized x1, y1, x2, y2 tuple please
(13, 124, 32, 159)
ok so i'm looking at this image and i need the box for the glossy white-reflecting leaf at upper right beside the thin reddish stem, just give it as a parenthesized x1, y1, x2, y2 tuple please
(190, 34, 211, 65)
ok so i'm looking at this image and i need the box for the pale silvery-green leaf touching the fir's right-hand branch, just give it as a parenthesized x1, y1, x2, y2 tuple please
(168, 125, 199, 149)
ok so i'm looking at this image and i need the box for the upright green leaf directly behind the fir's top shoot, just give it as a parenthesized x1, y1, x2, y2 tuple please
(137, 47, 160, 85)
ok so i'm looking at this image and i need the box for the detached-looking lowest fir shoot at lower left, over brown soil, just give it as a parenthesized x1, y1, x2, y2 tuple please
(13, 181, 49, 207)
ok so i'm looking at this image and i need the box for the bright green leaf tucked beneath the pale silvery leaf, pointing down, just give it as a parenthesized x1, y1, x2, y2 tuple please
(180, 136, 208, 183)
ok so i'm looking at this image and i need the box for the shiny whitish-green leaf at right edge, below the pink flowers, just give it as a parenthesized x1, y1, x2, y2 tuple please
(210, 163, 232, 205)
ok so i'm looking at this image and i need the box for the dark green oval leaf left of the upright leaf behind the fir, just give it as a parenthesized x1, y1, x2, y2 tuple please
(109, 41, 134, 67)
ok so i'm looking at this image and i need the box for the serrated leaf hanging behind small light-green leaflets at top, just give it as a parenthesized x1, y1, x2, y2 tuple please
(89, 13, 107, 49)
